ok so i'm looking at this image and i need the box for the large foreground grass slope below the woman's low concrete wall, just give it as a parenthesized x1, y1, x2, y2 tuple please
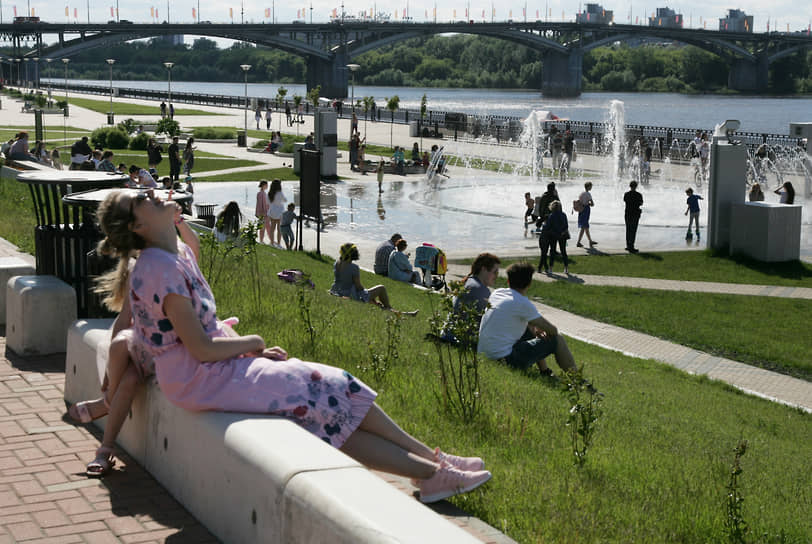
(202, 247, 812, 543)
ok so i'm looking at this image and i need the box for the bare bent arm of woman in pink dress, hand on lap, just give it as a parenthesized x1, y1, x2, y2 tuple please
(163, 293, 265, 362)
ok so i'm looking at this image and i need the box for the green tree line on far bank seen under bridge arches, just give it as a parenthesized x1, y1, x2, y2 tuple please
(22, 35, 812, 94)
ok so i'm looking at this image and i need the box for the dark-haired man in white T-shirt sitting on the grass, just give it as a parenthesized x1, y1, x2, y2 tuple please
(477, 263, 577, 377)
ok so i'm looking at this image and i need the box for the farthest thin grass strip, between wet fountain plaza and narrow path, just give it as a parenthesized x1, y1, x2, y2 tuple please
(482, 250, 812, 287)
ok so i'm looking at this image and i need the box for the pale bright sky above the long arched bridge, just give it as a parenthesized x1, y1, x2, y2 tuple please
(0, 0, 812, 32)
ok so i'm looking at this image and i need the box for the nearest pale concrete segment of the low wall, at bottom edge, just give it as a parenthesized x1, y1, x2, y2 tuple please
(279, 467, 480, 544)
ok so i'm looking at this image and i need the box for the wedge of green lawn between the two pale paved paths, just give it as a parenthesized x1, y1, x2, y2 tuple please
(520, 279, 812, 380)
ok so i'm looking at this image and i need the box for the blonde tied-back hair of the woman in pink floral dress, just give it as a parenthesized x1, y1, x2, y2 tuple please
(94, 191, 145, 312)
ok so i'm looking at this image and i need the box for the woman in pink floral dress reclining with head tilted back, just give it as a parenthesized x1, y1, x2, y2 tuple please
(93, 191, 482, 503)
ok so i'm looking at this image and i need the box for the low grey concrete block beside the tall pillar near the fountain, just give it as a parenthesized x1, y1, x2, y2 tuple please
(730, 202, 802, 262)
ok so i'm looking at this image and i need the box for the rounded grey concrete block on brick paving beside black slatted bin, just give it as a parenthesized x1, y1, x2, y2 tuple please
(6, 276, 76, 355)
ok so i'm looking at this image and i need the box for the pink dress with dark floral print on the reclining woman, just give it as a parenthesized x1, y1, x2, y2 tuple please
(130, 241, 377, 448)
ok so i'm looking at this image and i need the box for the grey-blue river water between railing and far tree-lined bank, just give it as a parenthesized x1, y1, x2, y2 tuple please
(53, 79, 812, 134)
